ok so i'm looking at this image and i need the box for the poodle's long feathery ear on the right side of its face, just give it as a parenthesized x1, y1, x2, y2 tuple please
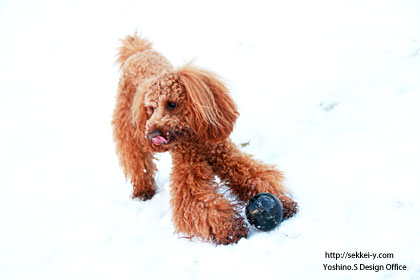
(178, 64, 239, 142)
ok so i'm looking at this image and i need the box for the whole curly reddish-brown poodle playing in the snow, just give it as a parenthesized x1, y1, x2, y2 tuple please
(112, 34, 297, 244)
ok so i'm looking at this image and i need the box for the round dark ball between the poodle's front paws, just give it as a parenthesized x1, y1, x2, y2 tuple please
(245, 193, 283, 231)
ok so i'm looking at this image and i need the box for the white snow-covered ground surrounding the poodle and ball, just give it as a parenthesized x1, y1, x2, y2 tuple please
(0, 0, 420, 280)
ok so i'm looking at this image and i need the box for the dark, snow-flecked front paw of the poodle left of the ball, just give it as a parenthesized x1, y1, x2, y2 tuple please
(212, 217, 249, 245)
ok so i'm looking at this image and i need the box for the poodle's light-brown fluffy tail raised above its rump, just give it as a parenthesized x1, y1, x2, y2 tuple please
(117, 32, 152, 68)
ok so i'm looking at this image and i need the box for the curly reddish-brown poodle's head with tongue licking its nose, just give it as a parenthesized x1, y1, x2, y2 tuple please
(132, 64, 239, 152)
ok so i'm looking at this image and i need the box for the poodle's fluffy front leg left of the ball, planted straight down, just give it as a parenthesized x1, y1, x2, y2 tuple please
(171, 160, 248, 245)
